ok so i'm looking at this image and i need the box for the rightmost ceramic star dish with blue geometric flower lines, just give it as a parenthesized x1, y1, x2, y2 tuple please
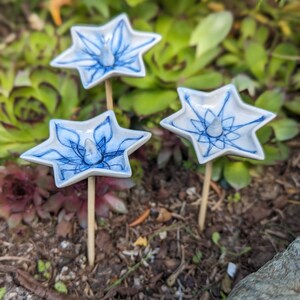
(161, 84, 275, 164)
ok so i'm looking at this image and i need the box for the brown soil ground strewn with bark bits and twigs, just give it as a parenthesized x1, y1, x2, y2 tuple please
(0, 151, 300, 300)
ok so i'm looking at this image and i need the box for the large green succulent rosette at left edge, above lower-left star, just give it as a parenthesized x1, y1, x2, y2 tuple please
(0, 68, 79, 157)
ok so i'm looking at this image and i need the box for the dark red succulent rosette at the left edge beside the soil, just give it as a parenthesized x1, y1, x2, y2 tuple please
(0, 163, 55, 227)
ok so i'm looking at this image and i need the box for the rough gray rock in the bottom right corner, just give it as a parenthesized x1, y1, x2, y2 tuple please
(227, 237, 300, 300)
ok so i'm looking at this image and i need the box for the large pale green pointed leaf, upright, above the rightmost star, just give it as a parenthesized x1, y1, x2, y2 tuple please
(190, 11, 233, 57)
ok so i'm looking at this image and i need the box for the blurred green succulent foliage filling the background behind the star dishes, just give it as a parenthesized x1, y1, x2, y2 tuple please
(0, 0, 300, 189)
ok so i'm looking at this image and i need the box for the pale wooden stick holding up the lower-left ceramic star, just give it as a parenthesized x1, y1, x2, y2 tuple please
(88, 176, 95, 267)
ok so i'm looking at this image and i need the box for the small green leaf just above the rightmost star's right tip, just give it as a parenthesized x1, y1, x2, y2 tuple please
(255, 89, 284, 113)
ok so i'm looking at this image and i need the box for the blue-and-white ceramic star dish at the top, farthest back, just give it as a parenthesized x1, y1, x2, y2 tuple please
(51, 14, 161, 89)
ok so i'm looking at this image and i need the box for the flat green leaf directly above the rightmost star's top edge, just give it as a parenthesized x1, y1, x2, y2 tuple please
(183, 72, 223, 90)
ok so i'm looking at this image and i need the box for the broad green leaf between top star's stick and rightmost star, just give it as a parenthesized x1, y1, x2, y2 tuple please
(119, 90, 177, 115)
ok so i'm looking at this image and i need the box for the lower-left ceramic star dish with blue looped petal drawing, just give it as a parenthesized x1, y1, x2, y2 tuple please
(21, 111, 151, 187)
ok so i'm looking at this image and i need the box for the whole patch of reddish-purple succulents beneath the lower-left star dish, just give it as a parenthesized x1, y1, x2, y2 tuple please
(0, 163, 134, 229)
